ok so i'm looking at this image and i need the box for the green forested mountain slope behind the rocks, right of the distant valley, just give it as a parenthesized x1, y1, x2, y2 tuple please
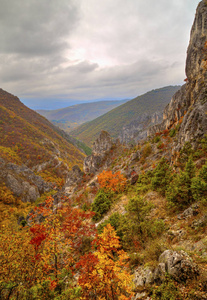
(70, 86, 179, 146)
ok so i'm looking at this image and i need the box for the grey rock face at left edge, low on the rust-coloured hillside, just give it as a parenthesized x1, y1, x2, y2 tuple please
(0, 158, 52, 202)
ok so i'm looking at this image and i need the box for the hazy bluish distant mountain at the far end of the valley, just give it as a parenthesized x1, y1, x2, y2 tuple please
(37, 100, 127, 132)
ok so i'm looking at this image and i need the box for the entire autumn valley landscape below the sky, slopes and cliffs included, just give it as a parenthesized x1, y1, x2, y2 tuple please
(0, 0, 207, 300)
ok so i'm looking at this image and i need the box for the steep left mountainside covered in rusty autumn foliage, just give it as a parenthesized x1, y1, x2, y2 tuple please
(0, 89, 85, 202)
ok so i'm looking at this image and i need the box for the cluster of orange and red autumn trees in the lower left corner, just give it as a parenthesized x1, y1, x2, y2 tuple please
(0, 197, 96, 299)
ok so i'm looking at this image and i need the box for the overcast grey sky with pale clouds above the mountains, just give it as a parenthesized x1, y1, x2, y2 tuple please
(0, 0, 199, 109)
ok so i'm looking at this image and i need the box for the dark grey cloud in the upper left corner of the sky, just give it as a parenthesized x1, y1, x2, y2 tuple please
(0, 0, 78, 56)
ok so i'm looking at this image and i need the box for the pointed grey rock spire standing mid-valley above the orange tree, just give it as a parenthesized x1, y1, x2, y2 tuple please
(83, 131, 113, 173)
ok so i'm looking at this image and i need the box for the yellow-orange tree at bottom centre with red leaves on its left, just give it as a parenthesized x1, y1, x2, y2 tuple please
(77, 224, 133, 300)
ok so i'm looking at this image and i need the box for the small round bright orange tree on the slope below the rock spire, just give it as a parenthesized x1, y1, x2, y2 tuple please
(98, 170, 127, 193)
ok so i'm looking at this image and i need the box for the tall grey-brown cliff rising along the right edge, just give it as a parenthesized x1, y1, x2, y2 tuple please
(148, 0, 207, 150)
